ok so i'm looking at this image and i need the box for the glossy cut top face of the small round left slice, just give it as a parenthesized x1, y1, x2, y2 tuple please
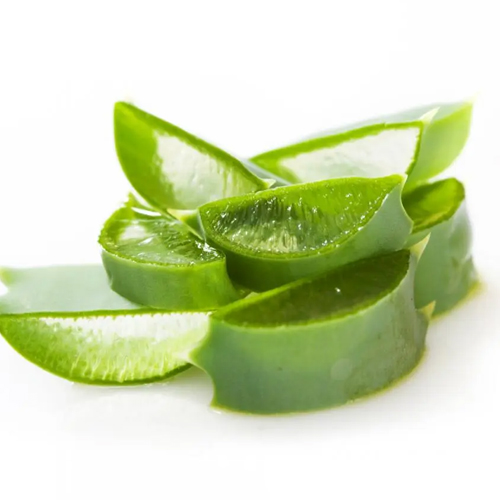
(100, 206, 223, 265)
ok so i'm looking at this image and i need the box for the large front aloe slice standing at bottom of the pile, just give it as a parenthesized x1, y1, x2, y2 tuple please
(189, 250, 430, 413)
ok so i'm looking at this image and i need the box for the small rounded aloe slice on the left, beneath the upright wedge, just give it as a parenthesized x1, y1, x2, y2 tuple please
(99, 197, 240, 311)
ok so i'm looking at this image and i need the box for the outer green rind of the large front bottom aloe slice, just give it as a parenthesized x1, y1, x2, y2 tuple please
(190, 252, 428, 414)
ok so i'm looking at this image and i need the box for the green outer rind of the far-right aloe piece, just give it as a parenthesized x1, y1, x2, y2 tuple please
(408, 202, 478, 315)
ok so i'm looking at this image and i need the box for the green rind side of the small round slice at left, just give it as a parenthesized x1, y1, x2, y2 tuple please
(101, 250, 241, 311)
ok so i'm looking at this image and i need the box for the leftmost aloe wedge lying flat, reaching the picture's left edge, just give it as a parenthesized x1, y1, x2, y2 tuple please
(0, 266, 208, 384)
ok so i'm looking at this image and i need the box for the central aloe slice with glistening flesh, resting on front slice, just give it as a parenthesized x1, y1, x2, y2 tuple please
(199, 175, 412, 291)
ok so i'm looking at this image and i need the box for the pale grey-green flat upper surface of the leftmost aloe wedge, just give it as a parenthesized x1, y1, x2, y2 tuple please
(0, 264, 142, 314)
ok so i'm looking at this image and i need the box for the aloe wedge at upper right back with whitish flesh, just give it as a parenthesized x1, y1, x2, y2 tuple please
(251, 101, 472, 187)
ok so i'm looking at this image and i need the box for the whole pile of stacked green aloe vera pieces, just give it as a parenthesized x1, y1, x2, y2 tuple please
(0, 98, 477, 413)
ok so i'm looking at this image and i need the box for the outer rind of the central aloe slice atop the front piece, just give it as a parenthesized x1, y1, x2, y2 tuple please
(202, 184, 412, 291)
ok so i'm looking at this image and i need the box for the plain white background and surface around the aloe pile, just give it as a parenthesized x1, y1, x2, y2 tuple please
(0, 0, 500, 500)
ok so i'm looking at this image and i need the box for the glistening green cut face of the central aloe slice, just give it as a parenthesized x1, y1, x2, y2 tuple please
(200, 176, 401, 255)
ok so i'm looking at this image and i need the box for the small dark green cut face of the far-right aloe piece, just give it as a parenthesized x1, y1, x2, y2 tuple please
(403, 179, 465, 233)
